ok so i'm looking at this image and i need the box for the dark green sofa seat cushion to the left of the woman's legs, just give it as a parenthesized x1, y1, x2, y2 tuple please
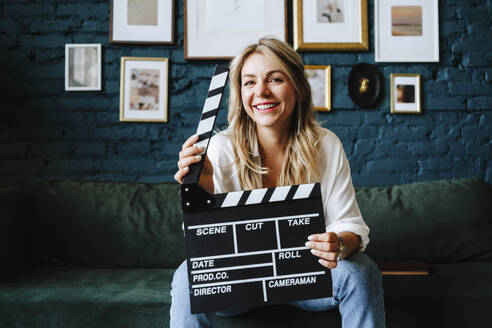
(0, 267, 174, 328)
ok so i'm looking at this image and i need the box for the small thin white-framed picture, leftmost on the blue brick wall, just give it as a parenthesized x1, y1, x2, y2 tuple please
(65, 43, 101, 91)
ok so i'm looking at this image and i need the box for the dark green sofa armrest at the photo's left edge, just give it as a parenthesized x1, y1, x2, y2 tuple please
(0, 188, 24, 277)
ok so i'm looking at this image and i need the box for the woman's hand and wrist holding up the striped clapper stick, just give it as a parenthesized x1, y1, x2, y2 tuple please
(174, 135, 214, 193)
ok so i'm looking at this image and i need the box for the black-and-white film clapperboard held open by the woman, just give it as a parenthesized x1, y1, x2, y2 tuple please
(181, 66, 332, 313)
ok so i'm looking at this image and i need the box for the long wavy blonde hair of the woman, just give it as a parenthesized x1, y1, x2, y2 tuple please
(228, 38, 325, 189)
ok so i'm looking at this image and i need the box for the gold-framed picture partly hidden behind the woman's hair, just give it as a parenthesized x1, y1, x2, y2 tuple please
(304, 65, 331, 112)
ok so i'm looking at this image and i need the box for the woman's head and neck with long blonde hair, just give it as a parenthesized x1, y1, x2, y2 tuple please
(228, 38, 326, 189)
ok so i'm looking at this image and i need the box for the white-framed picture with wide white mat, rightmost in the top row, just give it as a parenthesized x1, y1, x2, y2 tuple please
(374, 0, 439, 62)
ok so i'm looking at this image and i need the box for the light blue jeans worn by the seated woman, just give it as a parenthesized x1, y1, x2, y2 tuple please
(170, 252, 385, 328)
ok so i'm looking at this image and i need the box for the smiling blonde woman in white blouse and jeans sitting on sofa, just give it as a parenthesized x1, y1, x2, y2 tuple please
(171, 38, 384, 328)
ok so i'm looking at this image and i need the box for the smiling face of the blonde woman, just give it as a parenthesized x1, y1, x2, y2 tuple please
(241, 53, 296, 131)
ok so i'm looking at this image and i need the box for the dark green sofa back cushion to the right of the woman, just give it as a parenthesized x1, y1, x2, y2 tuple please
(356, 179, 492, 263)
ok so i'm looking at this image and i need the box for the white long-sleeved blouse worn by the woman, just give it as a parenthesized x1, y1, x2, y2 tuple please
(207, 130, 369, 251)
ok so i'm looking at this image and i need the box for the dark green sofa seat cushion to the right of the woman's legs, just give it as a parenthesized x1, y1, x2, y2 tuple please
(383, 261, 492, 328)
